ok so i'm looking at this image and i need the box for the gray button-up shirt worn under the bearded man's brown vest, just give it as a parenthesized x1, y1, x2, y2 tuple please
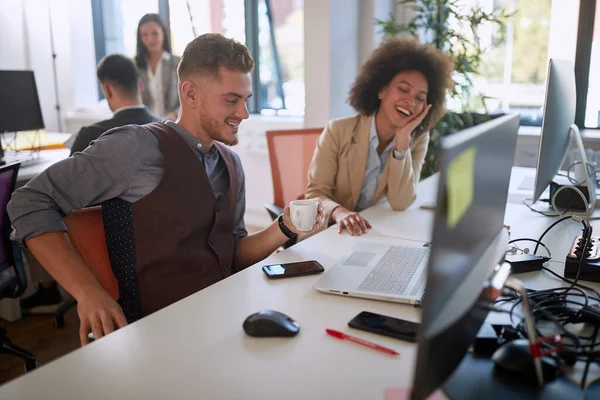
(7, 121, 248, 245)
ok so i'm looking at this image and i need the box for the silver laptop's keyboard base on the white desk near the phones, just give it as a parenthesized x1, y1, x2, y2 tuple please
(315, 243, 429, 304)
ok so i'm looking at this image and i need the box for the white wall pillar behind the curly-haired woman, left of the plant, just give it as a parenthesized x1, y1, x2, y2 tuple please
(304, 0, 394, 128)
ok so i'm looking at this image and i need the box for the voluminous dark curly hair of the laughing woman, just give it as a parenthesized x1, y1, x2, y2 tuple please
(348, 38, 454, 133)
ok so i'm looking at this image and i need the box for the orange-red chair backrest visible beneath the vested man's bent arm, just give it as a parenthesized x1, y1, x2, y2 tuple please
(64, 206, 119, 300)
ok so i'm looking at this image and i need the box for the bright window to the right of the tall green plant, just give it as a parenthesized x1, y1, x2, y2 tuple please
(454, 0, 578, 126)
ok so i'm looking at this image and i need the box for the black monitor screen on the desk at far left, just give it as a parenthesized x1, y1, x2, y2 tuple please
(0, 71, 44, 133)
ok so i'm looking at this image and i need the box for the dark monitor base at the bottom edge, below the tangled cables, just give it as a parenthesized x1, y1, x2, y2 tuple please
(442, 353, 585, 400)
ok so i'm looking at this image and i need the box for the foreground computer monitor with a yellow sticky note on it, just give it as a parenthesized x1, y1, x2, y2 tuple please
(412, 114, 519, 399)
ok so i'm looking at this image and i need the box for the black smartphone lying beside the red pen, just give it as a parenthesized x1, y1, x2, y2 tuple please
(348, 311, 420, 342)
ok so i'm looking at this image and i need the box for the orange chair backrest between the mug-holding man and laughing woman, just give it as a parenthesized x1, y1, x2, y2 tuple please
(267, 128, 323, 208)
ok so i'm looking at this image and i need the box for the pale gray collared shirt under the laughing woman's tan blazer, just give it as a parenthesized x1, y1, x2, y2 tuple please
(354, 115, 396, 212)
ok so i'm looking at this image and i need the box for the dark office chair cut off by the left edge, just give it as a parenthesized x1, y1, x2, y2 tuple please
(0, 163, 37, 371)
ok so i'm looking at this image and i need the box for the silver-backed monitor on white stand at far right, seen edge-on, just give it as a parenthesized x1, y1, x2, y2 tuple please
(533, 58, 596, 208)
